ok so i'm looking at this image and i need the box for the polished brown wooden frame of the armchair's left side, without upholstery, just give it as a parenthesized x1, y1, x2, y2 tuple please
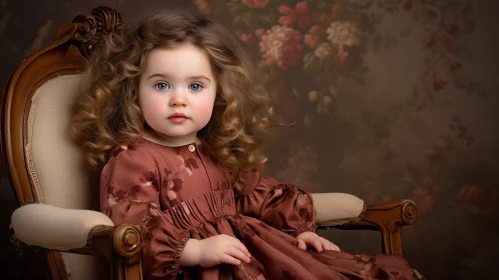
(0, 7, 142, 280)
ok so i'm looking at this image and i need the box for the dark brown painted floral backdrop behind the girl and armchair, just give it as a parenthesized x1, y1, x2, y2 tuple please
(0, 0, 499, 279)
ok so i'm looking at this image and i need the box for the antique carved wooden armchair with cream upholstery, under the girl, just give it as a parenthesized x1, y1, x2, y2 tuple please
(1, 7, 418, 280)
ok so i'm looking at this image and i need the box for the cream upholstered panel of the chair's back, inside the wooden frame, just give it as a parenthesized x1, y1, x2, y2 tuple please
(26, 74, 110, 280)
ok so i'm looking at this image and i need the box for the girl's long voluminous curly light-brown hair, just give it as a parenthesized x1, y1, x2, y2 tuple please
(70, 11, 272, 172)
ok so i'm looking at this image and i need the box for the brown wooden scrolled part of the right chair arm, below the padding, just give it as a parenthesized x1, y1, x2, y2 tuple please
(319, 199, 419, 255)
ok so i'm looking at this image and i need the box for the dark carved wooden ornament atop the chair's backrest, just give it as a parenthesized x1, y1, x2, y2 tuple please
(72, 7, 123, 58)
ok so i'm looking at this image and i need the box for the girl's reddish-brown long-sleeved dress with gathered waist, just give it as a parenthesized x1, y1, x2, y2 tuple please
(100, 139, 424, 280)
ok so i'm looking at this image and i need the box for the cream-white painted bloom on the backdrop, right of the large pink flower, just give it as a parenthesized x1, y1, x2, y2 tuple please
(326, 21, 361, 47)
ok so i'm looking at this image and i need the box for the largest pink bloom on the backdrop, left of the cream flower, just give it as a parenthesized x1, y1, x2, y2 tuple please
(259, 25, 303, 70)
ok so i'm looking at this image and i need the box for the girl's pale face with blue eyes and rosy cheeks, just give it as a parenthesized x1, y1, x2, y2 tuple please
(139, 44, 217, 146)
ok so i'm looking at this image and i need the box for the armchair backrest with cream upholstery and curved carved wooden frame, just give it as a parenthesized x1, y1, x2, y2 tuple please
(1, 7, 123, 280)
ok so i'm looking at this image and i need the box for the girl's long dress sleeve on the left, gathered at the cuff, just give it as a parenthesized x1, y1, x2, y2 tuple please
(100, 146, 189, 279)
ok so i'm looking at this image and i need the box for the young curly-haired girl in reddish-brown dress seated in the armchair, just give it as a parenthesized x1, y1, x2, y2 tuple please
(71, 9, 422, 280)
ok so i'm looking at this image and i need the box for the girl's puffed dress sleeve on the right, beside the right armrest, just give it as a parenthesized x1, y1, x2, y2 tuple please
(234, 170, 316, 237)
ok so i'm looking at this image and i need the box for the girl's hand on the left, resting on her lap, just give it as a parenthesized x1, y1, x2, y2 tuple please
(198, 234, 251, 267)
